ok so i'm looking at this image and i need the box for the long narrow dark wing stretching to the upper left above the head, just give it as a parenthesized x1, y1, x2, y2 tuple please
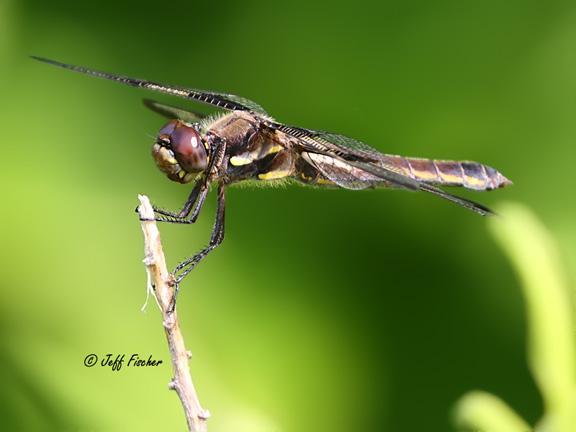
(31, 56, 266, 114)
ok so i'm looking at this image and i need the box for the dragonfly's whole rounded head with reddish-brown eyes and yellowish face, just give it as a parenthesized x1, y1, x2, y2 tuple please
(152, 120, 208, 183)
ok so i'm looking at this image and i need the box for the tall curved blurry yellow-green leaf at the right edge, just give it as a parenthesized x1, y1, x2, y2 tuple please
(490, 203, 576, 431)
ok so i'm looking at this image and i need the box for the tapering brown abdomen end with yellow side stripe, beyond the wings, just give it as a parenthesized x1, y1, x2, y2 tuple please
(384, 155, 512, 190)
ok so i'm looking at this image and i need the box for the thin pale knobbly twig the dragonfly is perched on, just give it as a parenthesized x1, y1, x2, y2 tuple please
(138, 195, 209, 432)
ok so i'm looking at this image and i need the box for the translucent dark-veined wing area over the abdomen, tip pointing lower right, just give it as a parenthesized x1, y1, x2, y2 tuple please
(267, 122, 494, 216)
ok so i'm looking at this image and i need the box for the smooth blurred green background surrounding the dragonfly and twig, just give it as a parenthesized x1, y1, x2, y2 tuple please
(0, 0, 576, 432)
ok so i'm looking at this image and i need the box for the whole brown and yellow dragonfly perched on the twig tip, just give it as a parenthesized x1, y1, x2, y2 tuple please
(32, 56, 511, 287)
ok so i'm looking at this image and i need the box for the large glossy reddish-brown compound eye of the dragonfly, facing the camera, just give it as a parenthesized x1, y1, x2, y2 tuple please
(170, 124, 208, 173)
